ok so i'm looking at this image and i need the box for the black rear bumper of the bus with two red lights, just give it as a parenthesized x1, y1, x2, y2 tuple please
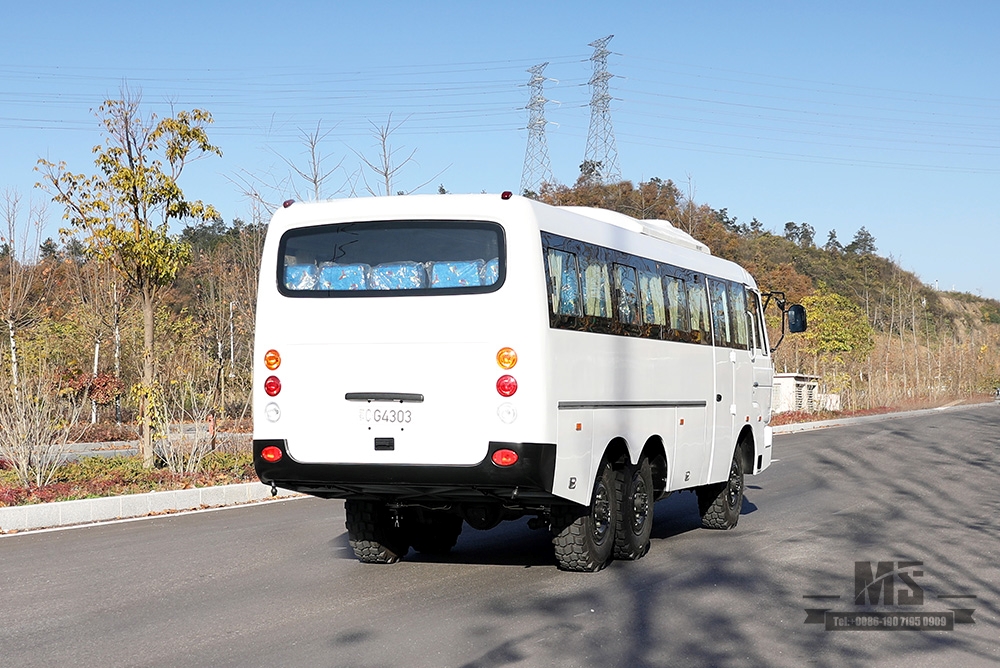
(253, 439, 556, 503)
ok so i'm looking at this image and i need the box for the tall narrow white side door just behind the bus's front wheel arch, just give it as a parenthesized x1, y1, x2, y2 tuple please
(708, 278, 737, 482)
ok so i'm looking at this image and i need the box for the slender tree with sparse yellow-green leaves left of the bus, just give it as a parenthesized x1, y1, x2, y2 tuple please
(38, 89, 222, 466)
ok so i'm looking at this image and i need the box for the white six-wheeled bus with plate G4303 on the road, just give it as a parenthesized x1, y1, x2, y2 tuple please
(253, 193, 804, 571)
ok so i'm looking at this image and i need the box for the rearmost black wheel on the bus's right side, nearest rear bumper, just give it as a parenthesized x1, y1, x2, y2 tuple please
(552, 461, 618, 572)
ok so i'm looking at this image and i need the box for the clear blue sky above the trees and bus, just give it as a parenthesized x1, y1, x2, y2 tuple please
(0, 0, 1000, 298)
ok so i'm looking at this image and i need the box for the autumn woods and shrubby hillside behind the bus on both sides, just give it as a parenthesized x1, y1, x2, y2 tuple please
(0, 175, 1000, 438)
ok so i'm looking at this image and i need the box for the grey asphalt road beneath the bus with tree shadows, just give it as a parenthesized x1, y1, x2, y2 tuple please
(0, 404, 1000, 668)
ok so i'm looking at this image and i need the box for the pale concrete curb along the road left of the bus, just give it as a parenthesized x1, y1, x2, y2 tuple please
(0, 482, 301, 535)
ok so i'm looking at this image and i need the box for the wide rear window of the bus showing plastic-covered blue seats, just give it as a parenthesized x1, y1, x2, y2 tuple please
(278, 220, 505, 297)
